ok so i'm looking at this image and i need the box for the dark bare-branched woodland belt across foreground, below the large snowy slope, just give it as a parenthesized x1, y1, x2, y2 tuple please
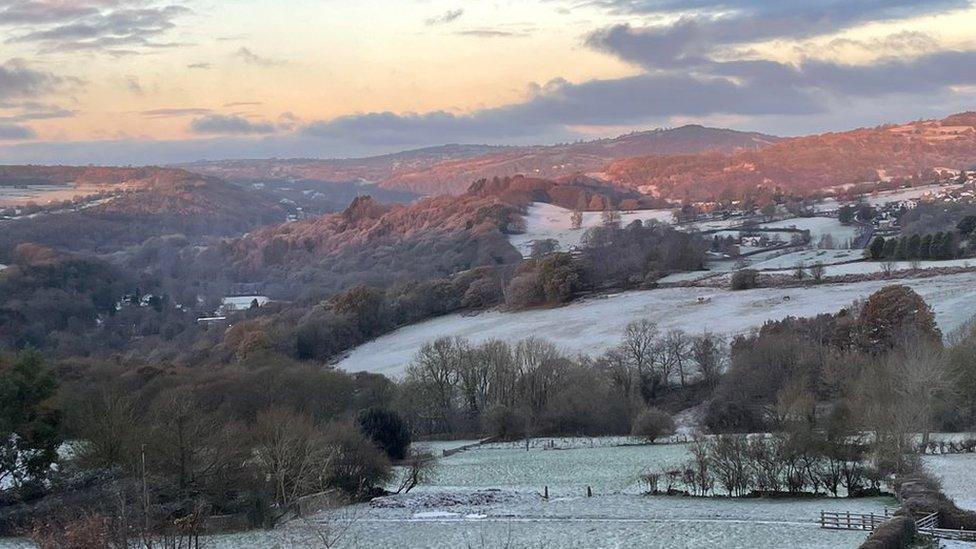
(0, 286, 976, 535)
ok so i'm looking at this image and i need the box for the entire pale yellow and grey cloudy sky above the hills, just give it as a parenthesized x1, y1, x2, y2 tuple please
(0, 0, 976, 164)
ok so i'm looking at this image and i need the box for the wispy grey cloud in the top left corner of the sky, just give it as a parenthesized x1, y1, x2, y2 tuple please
(0, 0, 190, 55)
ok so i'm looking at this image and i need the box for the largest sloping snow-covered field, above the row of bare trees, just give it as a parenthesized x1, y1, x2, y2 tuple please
(339, 273, 976, 376)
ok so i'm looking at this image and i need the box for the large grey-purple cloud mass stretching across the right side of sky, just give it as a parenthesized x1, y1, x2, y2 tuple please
(299, 0, 976, 152)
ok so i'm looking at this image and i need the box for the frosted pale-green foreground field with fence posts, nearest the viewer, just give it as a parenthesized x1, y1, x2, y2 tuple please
(207, 439, 895, 548)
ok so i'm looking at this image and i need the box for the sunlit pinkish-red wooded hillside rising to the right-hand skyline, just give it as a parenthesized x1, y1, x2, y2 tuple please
(605, 113, 976, 200)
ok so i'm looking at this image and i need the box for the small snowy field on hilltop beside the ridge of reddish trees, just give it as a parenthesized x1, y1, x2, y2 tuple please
(509, 202, 674, 256)
